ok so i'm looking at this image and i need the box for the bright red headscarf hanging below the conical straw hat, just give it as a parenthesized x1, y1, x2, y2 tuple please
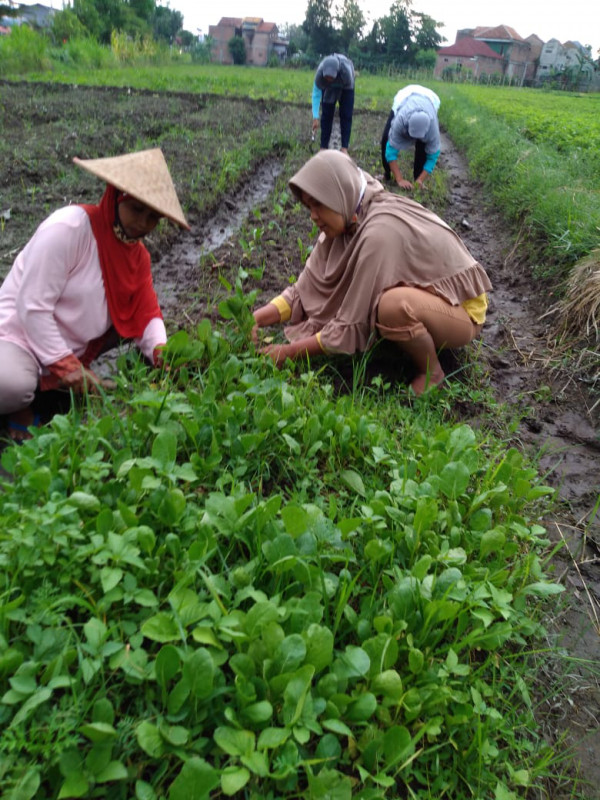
(82, 184, 162, 339)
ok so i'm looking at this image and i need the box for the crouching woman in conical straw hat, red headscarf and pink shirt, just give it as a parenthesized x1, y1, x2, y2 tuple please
(0, 148, 189, 440)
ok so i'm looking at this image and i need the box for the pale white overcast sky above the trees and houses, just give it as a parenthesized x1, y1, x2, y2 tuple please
(12, 0, 600, 58)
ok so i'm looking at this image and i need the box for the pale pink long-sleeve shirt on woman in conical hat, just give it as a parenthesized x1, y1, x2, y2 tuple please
(0, 206, 167, 374)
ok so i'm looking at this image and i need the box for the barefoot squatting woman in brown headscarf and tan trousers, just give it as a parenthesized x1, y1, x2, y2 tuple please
(253, 150, 491, 394)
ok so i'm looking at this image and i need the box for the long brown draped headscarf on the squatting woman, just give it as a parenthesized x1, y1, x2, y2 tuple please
(286, 150, 491, 353)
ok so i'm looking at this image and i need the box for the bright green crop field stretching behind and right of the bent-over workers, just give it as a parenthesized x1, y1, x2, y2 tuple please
(10, 65, 600, 276)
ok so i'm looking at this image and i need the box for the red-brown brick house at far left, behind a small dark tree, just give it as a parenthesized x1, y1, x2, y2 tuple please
(208, 17, 287, 67)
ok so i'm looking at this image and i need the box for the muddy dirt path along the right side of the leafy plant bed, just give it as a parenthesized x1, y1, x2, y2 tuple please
(442, 137, 600, 800)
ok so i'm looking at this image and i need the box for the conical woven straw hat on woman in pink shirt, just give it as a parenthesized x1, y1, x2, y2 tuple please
(73, 147, 190, 230)
